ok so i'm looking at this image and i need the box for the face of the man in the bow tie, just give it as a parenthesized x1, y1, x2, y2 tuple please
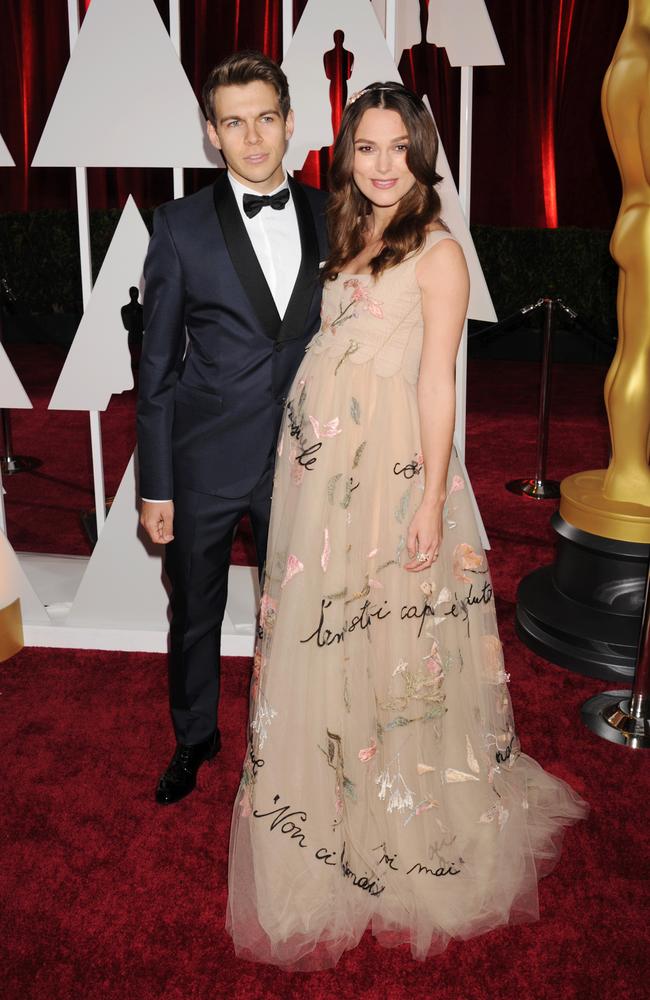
(208, 80, 293, 194)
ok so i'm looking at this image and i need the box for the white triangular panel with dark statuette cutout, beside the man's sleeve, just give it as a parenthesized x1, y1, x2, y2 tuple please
(49, 195, 149, 410)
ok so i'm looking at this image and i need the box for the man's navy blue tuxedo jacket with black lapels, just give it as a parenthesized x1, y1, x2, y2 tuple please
(138, 172, 327, 500)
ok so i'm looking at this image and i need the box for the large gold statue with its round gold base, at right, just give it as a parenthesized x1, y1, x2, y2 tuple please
(560, 0, 650, 544)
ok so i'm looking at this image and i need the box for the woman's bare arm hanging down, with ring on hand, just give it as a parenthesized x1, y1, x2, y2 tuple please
(405, 239, 469, 572)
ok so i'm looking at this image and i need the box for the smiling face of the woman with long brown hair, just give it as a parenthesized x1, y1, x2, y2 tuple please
(352, 108, 415, 208)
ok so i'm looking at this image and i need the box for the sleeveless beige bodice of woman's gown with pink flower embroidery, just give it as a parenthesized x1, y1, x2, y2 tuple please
(309, 230, 453, 384)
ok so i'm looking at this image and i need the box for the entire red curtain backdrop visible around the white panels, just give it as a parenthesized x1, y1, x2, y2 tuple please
(0, 0, 627, 228)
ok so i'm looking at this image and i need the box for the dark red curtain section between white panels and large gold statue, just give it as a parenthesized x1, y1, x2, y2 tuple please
(472, 0, 627, 228)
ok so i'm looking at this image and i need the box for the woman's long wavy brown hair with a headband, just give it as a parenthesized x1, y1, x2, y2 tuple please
(321, 82, 444, 281)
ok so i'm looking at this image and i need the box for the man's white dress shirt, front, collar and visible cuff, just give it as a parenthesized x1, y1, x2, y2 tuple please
(142, 172, 302, 503)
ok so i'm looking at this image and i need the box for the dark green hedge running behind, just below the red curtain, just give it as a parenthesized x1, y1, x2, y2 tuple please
(0, 211, 618, 337)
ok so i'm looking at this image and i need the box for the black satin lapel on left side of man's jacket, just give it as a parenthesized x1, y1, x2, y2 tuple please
(213, 171, 280, 340)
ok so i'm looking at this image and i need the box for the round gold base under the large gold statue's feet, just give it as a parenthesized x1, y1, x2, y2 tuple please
(560, 469, 650, 545)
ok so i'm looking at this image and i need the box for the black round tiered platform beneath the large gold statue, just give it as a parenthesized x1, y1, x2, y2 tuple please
(517, 514, 650, 681)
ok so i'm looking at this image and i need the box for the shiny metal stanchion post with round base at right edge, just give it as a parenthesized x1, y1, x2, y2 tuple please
(581, 564, 650, 750)
